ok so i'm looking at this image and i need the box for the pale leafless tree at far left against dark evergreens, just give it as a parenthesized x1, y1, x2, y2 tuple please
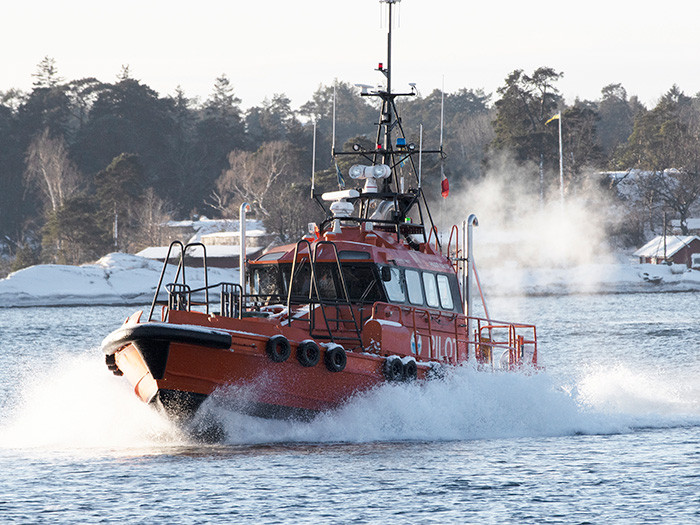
(24, 129, 79, 211)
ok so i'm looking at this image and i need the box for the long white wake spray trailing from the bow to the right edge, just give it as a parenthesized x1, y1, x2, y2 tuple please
(202, 366, 700, 444)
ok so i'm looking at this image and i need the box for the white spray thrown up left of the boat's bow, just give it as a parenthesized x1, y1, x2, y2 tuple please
(0, 349, 185, 452)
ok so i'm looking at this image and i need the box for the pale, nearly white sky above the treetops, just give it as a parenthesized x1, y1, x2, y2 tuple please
(0, 0, 700, 108)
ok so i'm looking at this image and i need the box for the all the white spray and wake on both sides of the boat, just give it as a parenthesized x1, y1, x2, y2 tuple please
(0, 351, 700, 455)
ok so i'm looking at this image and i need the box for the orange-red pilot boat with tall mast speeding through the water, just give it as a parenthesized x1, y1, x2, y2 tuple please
(102, 0, 537, 422)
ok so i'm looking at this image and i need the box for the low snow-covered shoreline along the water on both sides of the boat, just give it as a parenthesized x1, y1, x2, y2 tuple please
(0, 253, 700, 307)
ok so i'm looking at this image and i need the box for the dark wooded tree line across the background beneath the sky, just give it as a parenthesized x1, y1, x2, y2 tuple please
(0, 57, 700, 273)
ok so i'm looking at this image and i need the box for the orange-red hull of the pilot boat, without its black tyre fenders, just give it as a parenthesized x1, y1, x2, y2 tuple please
(104, 311, 430, 419)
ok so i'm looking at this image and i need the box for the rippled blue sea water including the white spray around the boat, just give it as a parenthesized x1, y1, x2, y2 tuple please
(0, 293, 700, 524)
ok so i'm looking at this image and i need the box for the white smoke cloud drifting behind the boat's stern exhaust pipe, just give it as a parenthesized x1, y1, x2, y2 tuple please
(432, 156, 616, 292)
